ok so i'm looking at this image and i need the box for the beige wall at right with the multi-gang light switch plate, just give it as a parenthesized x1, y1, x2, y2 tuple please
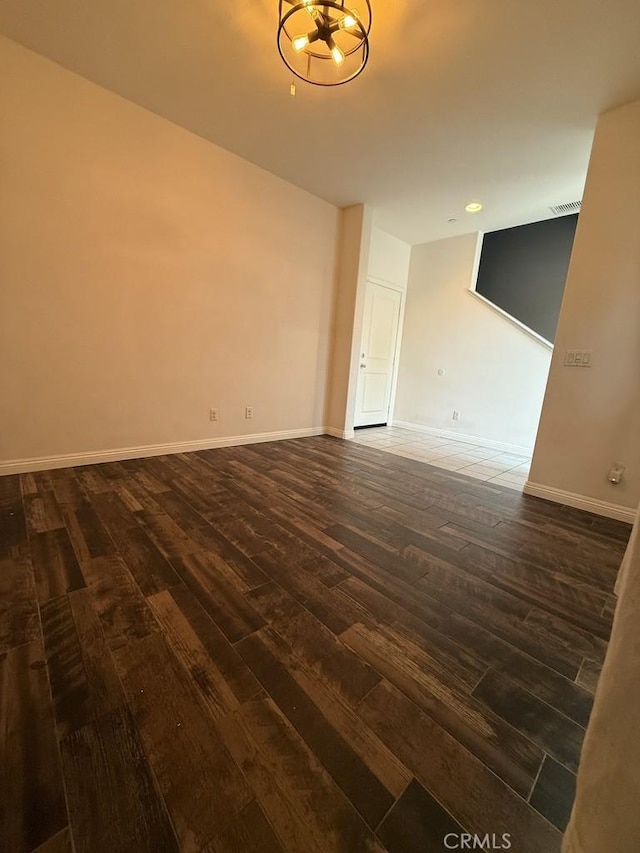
(530, 102, 640, 507)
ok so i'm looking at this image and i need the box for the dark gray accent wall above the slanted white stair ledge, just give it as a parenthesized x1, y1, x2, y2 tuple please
(476, 214, 578, 342)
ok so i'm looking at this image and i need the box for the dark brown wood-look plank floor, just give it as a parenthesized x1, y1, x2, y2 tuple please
(0, 438, 629, 853)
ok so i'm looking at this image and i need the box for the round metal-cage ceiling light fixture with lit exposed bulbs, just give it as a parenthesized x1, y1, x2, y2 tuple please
(278, 0, 371, 86)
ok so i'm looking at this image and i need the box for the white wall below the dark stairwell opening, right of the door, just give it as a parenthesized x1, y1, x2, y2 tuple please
(394, 234, 550, 449)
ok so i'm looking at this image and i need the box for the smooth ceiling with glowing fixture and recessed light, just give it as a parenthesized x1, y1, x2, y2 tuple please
(0, 0, 640, 243)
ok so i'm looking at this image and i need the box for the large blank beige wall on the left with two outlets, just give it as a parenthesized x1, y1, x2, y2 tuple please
(0, 38, 338, 470)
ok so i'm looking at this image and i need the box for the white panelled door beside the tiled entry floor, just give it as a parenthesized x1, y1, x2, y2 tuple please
(354, 281, 402, 426)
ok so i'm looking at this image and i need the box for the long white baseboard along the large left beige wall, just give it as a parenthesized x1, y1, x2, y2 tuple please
(0, 427, 328, 476)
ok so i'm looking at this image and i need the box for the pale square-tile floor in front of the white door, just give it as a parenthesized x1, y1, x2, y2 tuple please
(353, 427, 531, 491)
